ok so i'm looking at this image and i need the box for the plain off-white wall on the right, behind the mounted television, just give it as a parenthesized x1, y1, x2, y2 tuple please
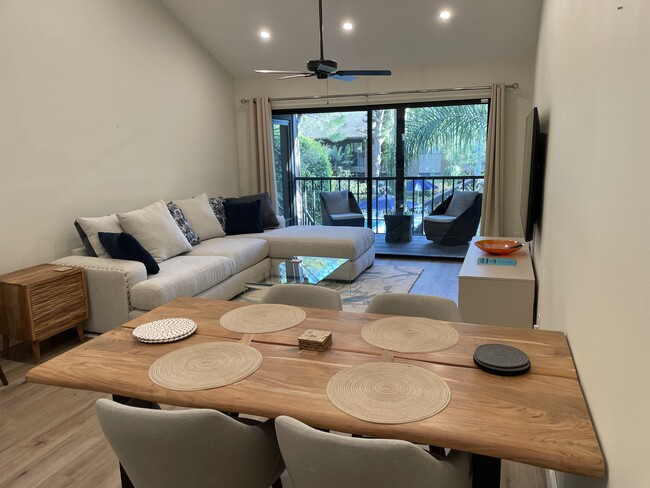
(534, 0, 650, 488)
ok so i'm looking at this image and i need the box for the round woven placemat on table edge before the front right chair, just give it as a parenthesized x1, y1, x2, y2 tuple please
(327, 363, 451, 424)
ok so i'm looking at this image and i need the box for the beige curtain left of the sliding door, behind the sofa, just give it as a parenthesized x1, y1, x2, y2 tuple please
(248, 97, 278, 212)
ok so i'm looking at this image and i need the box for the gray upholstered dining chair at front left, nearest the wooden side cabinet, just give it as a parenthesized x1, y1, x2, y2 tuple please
(96, 398, 284, 488)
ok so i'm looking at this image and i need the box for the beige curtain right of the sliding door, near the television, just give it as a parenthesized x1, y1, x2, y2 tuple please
(481, 83, 506, 237)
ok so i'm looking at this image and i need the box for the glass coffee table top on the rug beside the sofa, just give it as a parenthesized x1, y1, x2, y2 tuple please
(244, 256, 349, 290)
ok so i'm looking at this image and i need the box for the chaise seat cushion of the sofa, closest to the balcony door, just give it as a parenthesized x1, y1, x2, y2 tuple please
(234, 225, 375, 261)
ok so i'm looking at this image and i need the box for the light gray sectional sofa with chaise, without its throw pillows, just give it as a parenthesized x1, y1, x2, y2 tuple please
(55, 194, 375, 333)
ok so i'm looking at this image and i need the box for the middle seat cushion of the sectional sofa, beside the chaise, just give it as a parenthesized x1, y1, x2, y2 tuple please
(184, 238, 269, 275)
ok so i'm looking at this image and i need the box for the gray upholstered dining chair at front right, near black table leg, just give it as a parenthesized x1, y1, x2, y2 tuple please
(276, 416, 472, 488)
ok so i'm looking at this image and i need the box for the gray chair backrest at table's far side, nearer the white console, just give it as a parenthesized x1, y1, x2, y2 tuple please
(366, 293, 463, 322)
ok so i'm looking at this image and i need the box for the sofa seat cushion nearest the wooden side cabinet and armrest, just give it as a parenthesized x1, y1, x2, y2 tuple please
(130, 256, 232, 310)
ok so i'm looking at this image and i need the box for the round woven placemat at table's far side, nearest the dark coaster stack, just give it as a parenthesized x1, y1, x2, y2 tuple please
(361, 317, 458, 353)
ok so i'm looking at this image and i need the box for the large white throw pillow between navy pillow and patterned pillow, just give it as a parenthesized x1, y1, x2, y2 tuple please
(117, 200, 192, 263)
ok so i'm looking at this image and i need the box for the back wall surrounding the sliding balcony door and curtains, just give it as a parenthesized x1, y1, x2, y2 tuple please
(235, 56, 534, 236)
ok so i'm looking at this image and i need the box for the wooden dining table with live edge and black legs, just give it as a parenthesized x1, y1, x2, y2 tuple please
(26, 297, 606, 487)
